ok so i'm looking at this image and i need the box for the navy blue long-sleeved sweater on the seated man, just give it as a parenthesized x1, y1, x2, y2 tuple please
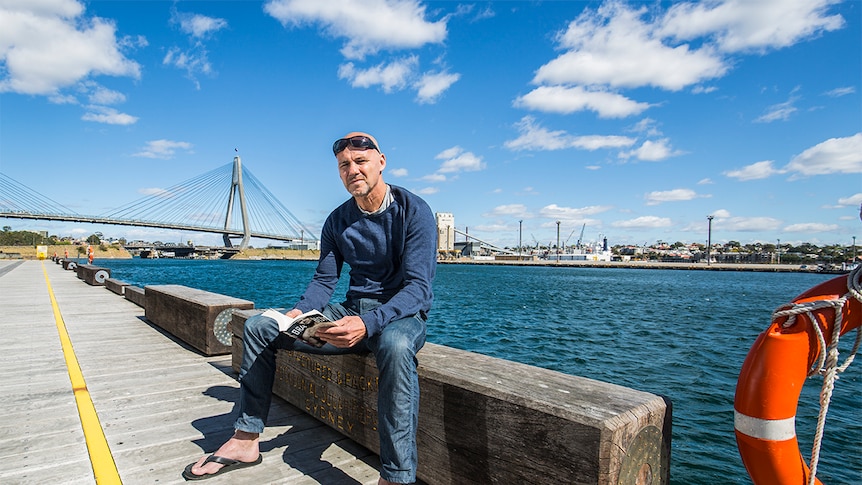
(296, 185, 437, 337)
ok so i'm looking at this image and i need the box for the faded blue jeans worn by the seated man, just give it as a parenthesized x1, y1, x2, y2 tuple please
(235, 299, 425, 483)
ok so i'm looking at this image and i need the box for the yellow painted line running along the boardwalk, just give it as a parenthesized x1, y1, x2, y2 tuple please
(42, 262, 123, 485)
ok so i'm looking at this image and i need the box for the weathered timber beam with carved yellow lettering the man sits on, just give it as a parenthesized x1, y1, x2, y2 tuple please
(231, 311, 671, 485)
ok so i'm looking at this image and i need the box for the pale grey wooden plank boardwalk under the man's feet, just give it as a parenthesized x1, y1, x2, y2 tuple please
(0, 261, 379, 485)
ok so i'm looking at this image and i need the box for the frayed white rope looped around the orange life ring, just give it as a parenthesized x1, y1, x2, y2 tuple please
(772, 266, 862, 485)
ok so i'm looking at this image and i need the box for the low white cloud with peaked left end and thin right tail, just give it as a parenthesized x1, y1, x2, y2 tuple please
(503, 116, 635, 151)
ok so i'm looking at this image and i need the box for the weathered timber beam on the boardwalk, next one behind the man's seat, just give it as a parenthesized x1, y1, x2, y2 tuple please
(144, 285, 254, 355)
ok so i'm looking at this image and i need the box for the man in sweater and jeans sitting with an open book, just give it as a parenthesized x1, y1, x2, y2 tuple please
(183, 132, 437, 485)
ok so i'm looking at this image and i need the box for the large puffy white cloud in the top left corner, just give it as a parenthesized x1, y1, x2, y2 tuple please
(0, 0, 141, 96)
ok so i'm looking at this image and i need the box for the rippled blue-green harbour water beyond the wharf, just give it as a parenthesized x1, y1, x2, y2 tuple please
(95, 259, 862, 485)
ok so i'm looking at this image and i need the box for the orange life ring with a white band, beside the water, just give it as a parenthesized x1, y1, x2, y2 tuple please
(734, 276, 862, 485)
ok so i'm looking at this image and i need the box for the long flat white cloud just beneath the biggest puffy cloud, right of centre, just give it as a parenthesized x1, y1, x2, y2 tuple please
(513, 86, 650, 118)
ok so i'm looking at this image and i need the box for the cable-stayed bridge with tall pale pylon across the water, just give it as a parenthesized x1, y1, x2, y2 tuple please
(0, 157, 314, 249)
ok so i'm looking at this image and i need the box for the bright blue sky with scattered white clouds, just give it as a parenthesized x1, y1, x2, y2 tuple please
(0, 0, 862, 247)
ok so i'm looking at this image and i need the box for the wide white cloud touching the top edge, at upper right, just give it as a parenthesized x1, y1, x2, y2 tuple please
(661, 0, 844, 52)
